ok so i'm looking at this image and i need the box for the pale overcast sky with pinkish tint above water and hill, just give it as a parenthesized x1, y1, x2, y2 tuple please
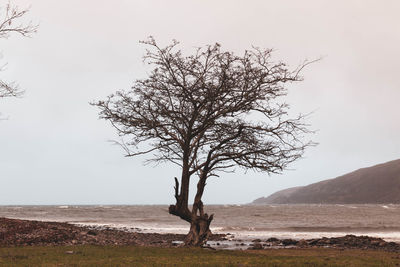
(0, 0, 400, 205)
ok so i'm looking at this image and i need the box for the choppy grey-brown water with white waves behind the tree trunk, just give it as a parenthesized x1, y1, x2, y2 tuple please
(0, 205, 400, 243)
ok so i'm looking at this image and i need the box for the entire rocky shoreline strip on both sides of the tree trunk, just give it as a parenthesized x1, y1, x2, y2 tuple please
(0, 218, 400, 252)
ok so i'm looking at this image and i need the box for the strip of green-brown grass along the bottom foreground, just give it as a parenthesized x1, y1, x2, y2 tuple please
(0, 246, 400, 266)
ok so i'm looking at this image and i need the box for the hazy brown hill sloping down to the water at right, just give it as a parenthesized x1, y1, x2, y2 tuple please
(252, 159, 400, 204)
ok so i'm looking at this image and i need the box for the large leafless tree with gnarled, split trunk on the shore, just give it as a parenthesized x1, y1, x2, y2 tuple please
(92, 38, 311, 246)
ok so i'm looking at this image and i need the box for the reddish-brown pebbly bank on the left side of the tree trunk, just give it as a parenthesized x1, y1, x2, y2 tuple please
(0, 218, 224, 247)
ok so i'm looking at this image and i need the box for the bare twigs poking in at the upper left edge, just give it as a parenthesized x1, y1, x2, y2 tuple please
(0, 2, 38, 98)
